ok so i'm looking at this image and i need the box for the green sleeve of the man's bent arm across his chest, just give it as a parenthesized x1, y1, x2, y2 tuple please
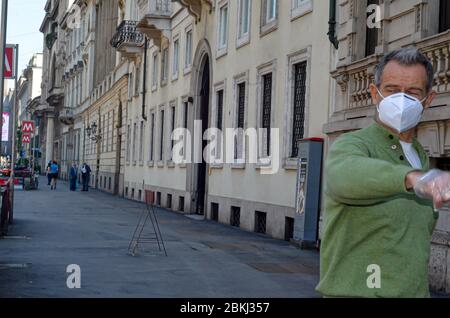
(325, 135, 415, 205)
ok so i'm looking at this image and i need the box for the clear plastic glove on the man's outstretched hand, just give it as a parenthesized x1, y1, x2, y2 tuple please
(414, 169, 450, 211)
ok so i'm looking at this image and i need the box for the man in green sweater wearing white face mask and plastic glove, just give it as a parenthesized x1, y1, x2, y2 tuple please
(317, 48, 450, 297)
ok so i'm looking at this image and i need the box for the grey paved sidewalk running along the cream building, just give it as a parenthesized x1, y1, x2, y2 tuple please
(0, 179, 319, 298)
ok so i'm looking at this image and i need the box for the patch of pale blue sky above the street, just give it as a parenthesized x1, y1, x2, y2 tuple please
(7, 0, 46, 85)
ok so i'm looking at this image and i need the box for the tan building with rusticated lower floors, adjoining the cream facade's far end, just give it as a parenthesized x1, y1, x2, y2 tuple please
(80, 0, 129, 195)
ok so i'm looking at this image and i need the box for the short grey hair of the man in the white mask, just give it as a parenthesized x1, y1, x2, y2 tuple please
(375, 47, 434, 91)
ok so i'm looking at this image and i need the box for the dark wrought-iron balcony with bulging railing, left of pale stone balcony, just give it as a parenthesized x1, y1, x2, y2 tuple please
(111, 20, 144, 57)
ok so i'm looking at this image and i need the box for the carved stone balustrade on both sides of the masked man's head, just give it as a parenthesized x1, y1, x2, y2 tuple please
(324, 30, 450, 133)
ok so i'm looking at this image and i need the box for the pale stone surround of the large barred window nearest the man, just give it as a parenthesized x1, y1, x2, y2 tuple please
(282, 47, 312, 169)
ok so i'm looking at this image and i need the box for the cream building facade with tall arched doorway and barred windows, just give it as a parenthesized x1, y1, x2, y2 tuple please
(113, 0, 331, 239)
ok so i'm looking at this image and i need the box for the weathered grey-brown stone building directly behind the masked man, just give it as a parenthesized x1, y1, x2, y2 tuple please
(324, 0, 450, 292)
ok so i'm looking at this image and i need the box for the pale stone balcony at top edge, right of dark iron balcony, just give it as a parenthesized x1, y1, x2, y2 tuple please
(137, 0, 172, 47)
